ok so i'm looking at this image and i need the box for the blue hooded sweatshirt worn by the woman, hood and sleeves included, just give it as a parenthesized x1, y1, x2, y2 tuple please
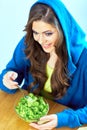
(0, 0, 87, 128)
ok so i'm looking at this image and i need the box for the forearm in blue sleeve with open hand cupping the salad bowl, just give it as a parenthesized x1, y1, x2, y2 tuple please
(29, 106, 87, 130)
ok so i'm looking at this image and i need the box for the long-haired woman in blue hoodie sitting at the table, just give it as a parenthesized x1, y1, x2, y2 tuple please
(0, 0, 87, 130)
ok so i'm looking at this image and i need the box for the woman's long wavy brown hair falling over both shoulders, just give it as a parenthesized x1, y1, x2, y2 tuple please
(25, 3, 69, 98)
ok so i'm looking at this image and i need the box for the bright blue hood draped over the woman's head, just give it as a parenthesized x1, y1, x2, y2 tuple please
(32, 0, 87, 75)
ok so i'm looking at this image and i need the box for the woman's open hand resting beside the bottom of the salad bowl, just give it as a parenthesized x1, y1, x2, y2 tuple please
(29, 114, 58, 130)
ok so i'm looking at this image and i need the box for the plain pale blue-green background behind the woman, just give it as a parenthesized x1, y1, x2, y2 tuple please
(0, 0, 87, 73)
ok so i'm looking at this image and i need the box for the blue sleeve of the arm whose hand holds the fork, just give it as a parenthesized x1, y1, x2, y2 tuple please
(0, 37, 26, 93)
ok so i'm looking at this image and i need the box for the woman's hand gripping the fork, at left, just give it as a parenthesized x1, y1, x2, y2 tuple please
(3, 71, 18, 89)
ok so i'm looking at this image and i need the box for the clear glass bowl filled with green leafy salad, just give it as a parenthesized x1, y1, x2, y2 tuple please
(15, 93, 49, 123)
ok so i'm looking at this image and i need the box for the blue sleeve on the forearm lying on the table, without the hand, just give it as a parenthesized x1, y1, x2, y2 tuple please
(57, 106, 87, 128)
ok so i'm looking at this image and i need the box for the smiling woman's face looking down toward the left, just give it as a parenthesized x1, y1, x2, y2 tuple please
(32, 21, 59, 53)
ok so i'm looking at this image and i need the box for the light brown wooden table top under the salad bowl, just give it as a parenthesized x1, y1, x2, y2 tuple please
(0, 90, 80, 130)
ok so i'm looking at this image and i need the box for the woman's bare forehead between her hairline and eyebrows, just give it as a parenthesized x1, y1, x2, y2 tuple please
(32, 21, 56, 32)
